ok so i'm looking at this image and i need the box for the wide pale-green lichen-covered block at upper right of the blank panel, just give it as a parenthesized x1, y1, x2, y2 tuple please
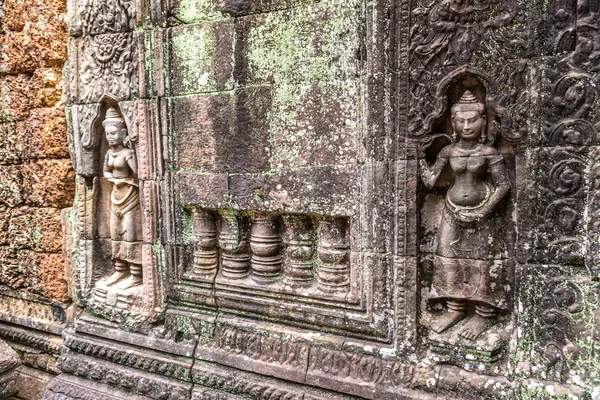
(241, 0, 361, 85)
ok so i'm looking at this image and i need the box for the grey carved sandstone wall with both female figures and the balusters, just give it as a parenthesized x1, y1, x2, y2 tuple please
(2, 0, 600, 400)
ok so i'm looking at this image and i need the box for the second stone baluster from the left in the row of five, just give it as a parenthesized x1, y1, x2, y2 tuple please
(219, 210, 250, 279)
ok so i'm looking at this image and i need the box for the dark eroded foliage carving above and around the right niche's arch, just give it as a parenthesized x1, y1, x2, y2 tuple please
(408, 0, 529, 137)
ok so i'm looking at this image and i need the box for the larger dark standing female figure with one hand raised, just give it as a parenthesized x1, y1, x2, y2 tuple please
(421, 90, 510, 340)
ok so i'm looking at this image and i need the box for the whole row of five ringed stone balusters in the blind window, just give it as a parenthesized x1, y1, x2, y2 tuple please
(186, 208, 350, 292)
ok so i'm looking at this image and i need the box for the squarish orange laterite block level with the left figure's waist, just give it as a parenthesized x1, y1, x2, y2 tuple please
(22, 159, 75, 207)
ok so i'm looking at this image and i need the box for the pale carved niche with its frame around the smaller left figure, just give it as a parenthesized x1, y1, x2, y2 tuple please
(71, 95, 159, 326)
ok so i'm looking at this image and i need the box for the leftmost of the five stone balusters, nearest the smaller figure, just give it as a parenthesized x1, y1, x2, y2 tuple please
(192, 209, 218, 279)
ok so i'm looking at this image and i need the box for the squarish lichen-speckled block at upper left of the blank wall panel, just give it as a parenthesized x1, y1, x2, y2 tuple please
(167, 20, 234, 95)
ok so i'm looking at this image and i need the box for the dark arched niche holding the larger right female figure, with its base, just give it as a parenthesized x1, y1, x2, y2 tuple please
(419, 66, 521, 365)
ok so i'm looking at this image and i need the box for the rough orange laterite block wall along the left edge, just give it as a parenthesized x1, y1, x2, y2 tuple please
(0, 0, 75, 397)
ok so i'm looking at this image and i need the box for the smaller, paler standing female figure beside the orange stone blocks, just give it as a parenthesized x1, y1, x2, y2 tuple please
(102, 107, 142, 289)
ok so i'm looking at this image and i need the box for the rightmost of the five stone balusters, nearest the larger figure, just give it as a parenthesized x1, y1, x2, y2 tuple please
(317, 218, 350, 292)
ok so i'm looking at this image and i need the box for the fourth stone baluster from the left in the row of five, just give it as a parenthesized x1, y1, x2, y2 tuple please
(283, 215, 314, 287)
